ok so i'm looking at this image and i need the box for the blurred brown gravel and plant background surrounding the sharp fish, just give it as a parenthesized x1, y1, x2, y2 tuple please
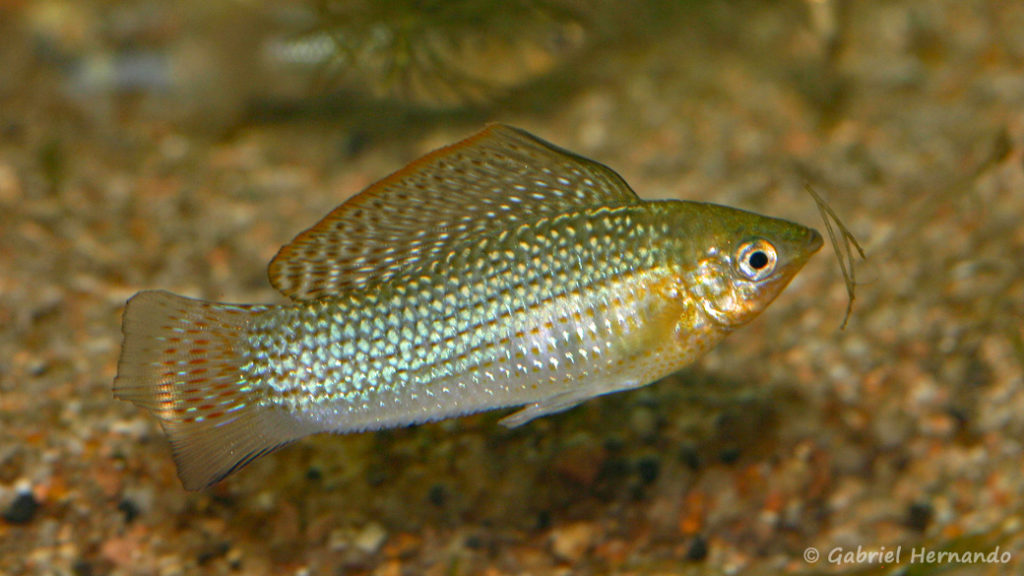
(0, 0, 1024, 576)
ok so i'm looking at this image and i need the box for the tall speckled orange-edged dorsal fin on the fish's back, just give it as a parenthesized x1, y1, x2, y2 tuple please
(269, 124, 639, 300)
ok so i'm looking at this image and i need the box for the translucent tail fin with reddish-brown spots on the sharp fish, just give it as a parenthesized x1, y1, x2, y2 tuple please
(114, 291, 314, 490)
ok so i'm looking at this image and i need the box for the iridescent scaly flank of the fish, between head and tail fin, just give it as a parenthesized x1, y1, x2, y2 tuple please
(247, 205, 696, 431)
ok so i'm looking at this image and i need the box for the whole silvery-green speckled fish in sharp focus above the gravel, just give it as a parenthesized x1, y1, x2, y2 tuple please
(114, 124, 822, 490)
